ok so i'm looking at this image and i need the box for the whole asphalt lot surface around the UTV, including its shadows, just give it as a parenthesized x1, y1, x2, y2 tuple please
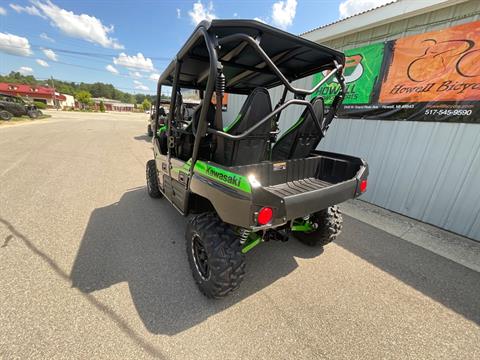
(0, 112, 480, 359)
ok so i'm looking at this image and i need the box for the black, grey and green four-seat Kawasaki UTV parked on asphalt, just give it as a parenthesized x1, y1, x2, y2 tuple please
(147, 20, 368, 298)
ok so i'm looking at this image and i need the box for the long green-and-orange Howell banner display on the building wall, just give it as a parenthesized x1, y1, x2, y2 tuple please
(313, 21, 480, 123)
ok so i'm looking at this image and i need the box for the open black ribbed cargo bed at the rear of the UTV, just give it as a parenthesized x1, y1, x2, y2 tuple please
(211, 151, 368, 226)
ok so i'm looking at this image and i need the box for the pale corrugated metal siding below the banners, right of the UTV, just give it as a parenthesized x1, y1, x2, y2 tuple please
(320, 119, 480, 240)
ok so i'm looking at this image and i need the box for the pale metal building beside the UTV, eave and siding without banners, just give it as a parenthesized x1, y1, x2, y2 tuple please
(224, 0, 480, 240)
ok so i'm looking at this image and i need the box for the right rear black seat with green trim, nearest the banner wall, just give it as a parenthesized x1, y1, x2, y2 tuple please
(272, 97, 324, 161)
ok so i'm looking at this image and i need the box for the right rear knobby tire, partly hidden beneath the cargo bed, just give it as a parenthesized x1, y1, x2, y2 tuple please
(294, 205, 343, 246)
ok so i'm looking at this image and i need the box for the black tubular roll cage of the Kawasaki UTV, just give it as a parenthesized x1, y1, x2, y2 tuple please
(154, 22, 346, 183)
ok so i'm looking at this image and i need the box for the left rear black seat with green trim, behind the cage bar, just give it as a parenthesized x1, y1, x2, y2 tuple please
(213, 88, 272, 166)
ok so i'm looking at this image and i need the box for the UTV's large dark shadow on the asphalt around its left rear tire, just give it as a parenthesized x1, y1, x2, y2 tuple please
(70, 188, 323, 335)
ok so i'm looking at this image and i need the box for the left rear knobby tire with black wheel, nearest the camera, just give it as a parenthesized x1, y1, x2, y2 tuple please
(185, 213, 245, 299)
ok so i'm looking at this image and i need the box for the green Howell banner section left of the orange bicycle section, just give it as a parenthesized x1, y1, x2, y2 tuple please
(312, 43, 384, 105)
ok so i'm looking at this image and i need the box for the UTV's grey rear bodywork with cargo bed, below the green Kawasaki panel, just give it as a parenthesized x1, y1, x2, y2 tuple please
(191, 151, 368, 230)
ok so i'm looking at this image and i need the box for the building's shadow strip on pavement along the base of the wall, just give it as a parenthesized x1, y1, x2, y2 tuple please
(336, 215, 480, 324)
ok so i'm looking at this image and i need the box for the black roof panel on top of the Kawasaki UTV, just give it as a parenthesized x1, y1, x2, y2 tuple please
(159, 20, 345, 93)
